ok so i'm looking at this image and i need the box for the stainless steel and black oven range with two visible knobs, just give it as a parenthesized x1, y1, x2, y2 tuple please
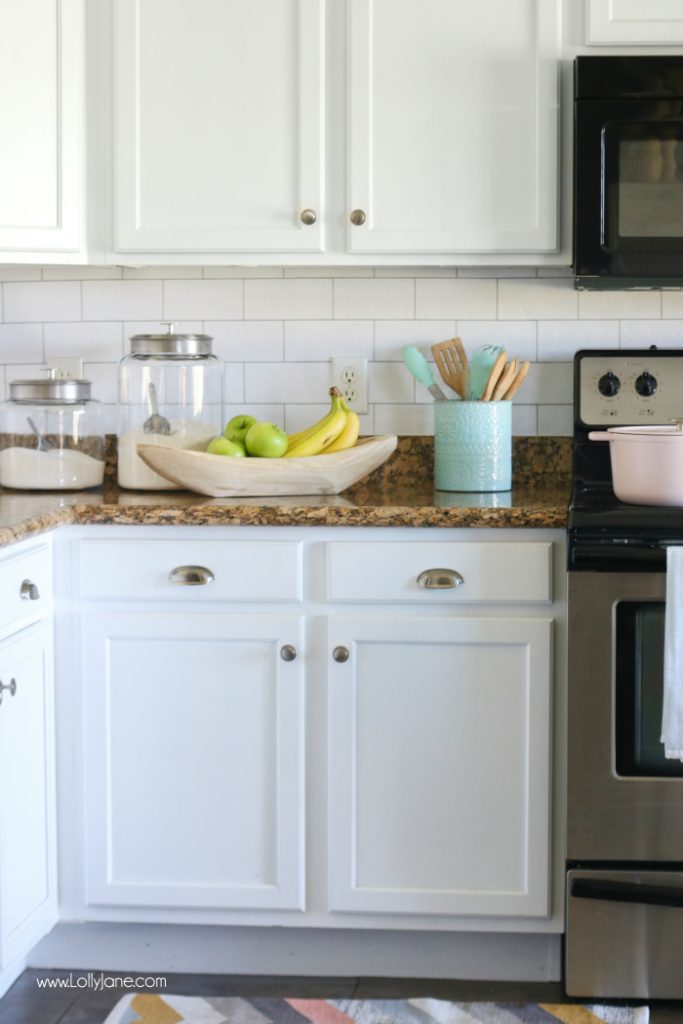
(565, 350, 683, 998)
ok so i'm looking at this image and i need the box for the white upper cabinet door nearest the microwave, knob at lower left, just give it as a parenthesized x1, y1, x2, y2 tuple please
(348, 0, 559, 253)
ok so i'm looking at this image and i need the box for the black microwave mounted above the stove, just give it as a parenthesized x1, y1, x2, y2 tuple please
(573, 56, 683, 288)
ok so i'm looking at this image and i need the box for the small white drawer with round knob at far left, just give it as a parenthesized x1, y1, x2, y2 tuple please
(0, 544, 52, 632)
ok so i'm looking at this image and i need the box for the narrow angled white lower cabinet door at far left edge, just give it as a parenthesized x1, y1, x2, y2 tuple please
(0, 626, 56, 969)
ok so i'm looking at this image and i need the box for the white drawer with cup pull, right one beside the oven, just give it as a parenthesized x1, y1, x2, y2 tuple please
(328, 541, 552, 604)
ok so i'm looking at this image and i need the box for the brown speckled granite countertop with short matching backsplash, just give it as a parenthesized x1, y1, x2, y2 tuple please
(0, 437, 569, 546)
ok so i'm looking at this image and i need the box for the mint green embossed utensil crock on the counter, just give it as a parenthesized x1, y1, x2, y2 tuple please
(434, 399, 512, 490)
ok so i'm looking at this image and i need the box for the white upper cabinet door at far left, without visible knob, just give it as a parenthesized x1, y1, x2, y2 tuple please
(0, 0, 85, 261)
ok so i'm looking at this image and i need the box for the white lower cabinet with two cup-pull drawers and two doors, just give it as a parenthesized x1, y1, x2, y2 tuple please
(65, 526, 564, 933)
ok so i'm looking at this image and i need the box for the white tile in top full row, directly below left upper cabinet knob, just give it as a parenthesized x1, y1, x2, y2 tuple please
(244, 278, 334, 319)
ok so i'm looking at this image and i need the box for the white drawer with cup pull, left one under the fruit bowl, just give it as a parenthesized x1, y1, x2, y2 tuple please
(80, 540, 301, 601)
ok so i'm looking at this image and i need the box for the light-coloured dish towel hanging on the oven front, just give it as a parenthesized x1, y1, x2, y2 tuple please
(661, 546, 683, 761)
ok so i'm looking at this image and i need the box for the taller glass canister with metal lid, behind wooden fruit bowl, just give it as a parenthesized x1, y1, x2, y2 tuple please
(118, 324, 223, 490)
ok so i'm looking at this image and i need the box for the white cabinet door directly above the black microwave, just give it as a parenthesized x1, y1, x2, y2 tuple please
(586, 0, 683, 46)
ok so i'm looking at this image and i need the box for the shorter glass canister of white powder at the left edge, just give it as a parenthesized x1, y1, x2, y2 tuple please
(0, 378, 104, 490)
